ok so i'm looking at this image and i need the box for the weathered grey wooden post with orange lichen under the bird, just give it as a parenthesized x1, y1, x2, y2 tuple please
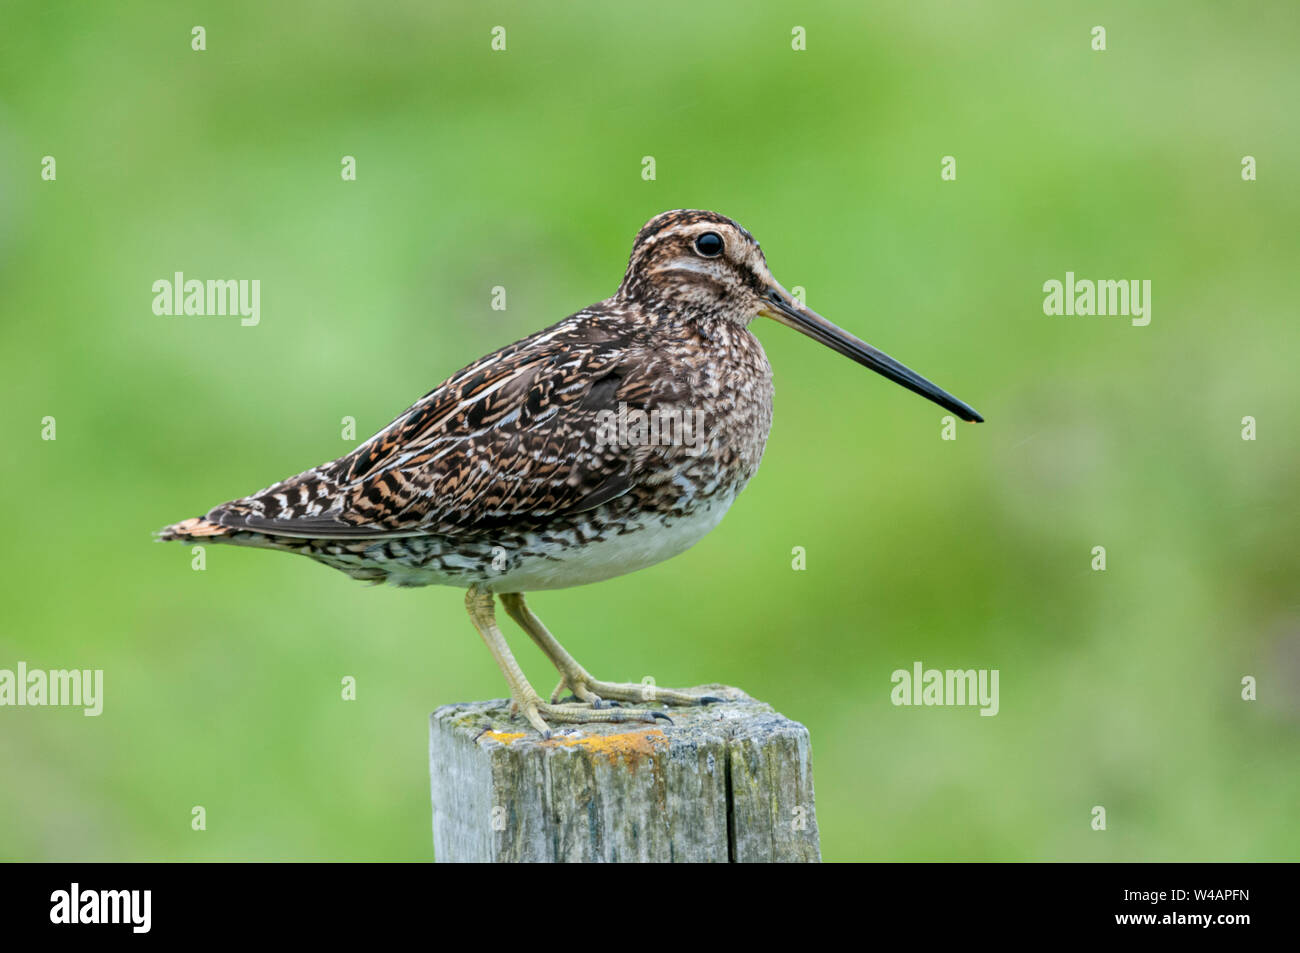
(429, 685, 822, 863)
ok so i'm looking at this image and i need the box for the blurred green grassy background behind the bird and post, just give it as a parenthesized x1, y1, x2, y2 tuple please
(0, 0, 1300, 861)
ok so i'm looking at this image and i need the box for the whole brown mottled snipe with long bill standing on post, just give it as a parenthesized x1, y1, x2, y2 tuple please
(159, 211, 982, 736)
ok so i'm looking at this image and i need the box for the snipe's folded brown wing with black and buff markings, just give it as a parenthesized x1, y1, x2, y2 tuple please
(205, 312, 684, 538)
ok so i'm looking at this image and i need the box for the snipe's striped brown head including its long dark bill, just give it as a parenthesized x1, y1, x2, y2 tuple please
(618, 209, 984, 423)
